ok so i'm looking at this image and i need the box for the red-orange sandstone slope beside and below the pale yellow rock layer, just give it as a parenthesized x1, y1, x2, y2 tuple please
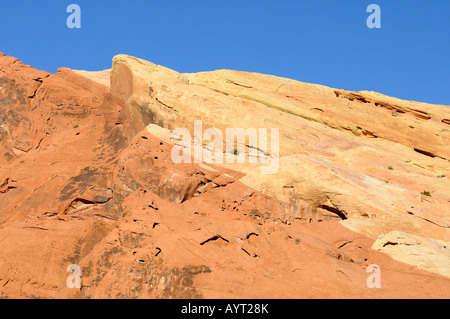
(0, 54, 450, 298)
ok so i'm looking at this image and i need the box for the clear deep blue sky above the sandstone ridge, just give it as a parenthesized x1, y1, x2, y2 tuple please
(0, 0, 450, 105)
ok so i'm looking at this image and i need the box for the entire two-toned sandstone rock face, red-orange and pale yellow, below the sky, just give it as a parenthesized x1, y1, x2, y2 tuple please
(0, 54, 450, 298)
